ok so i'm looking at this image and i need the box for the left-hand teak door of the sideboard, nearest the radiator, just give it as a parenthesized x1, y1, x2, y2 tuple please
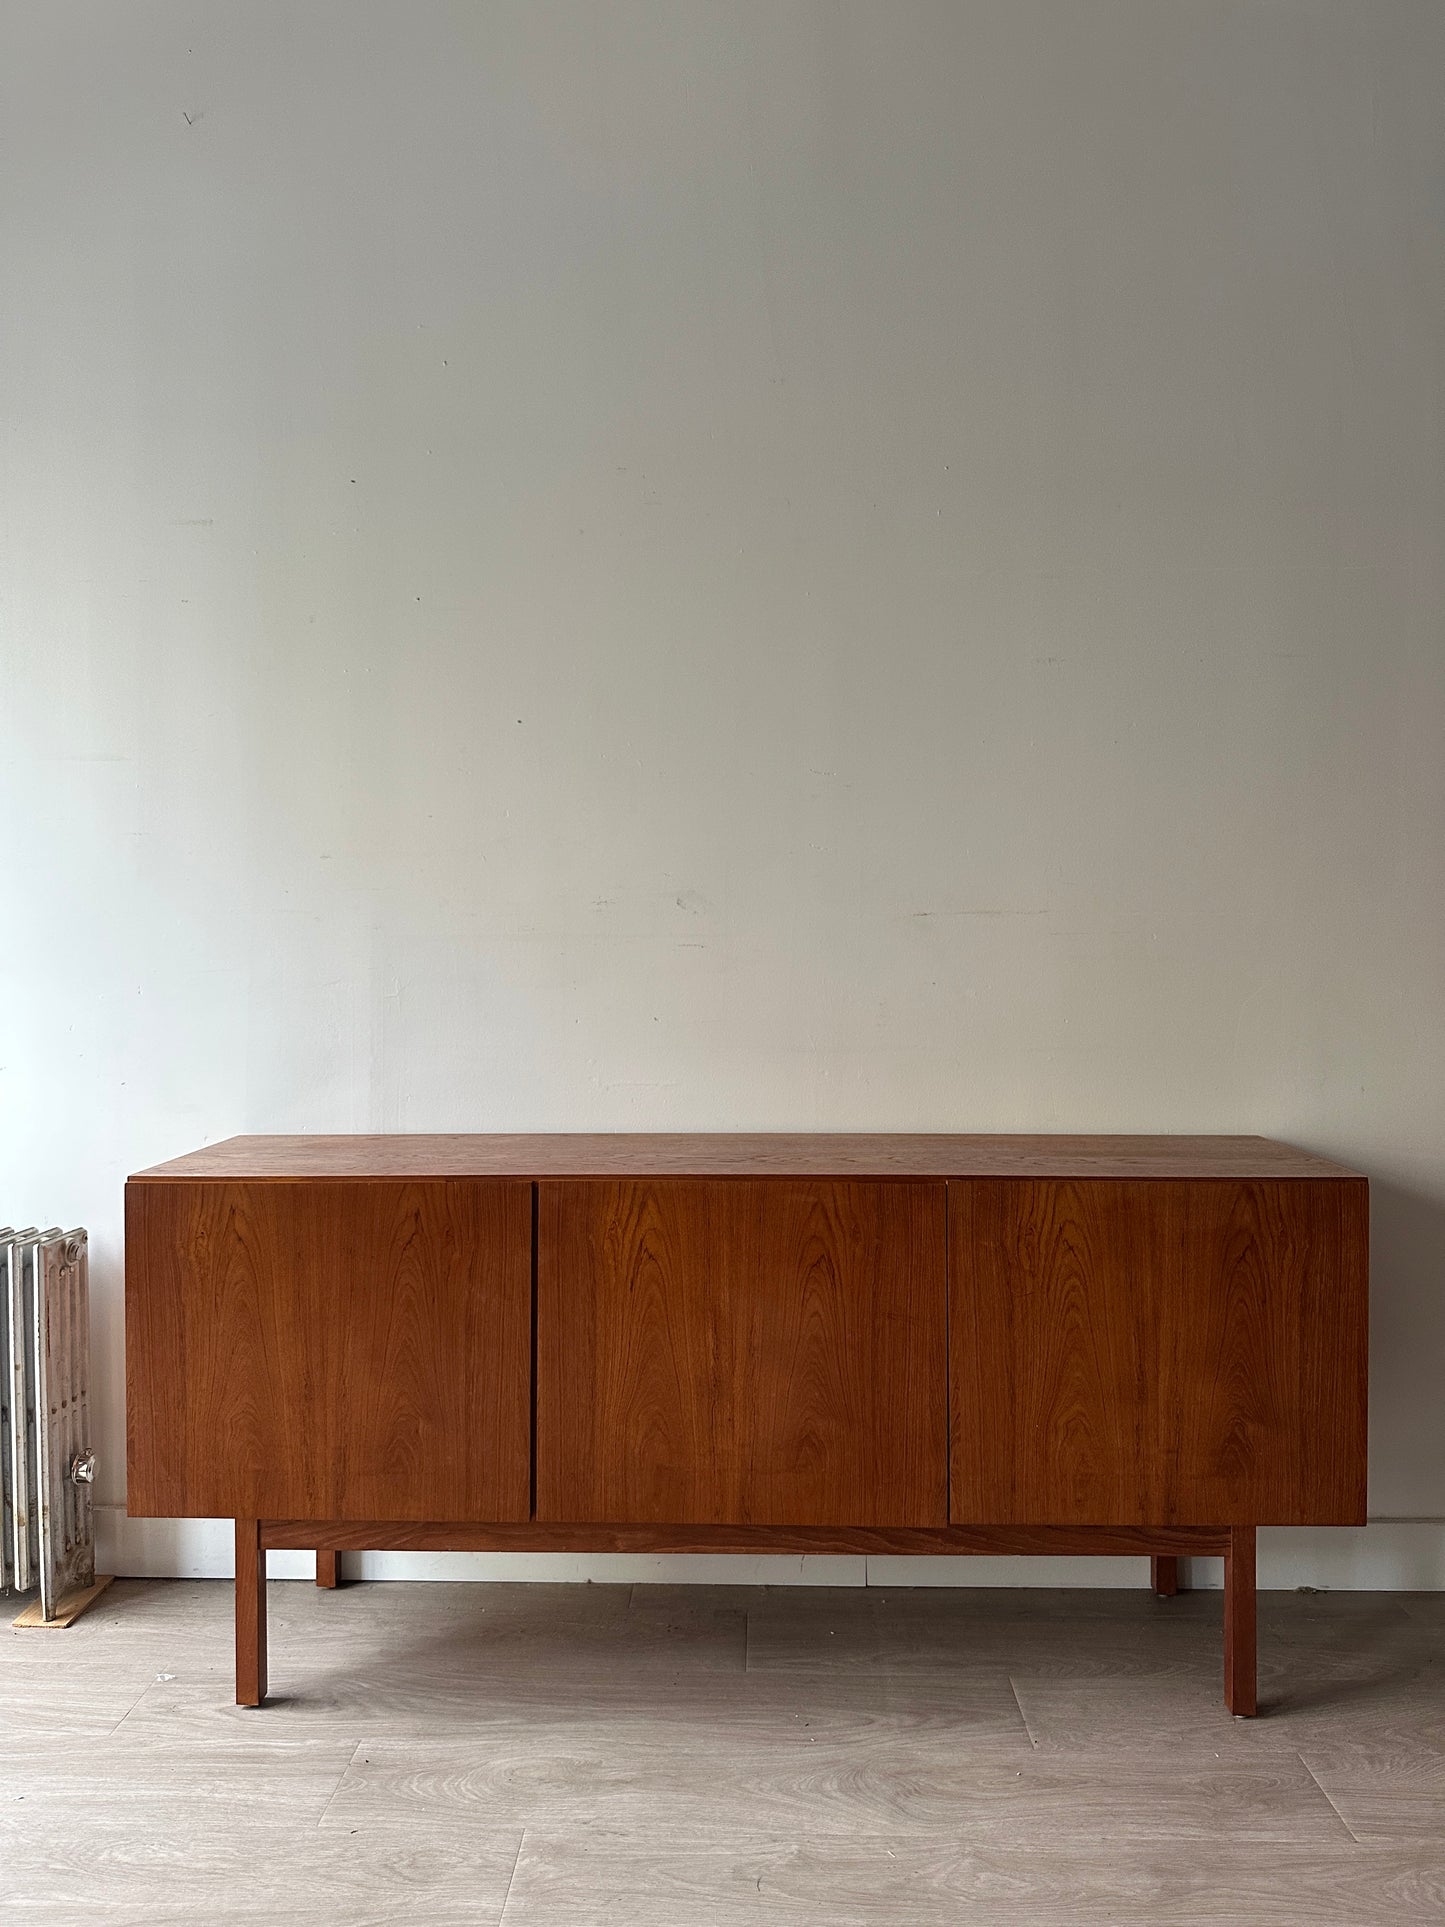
(125, 1181, 532, 1520)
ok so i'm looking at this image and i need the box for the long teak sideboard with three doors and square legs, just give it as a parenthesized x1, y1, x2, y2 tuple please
(125, 1135, 1368, 1713)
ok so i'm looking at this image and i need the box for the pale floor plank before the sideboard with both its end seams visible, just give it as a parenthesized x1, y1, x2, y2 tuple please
(322, 1742, 1349, 1850)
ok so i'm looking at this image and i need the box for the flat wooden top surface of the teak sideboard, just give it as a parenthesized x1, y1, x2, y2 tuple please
(133, 1131, 1360, 1181)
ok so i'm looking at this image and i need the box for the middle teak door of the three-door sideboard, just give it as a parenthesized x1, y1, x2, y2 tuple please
(538, 1179, 948, 1526)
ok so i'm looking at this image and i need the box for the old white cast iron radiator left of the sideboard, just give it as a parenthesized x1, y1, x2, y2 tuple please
(0, 1229, 94, 1619)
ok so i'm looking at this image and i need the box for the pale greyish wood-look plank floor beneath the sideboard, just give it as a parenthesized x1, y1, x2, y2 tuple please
(0, 1582, 1445, 1927)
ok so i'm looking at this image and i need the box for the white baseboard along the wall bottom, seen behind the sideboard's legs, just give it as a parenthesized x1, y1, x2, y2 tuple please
(96, 1505, 1445, 1592)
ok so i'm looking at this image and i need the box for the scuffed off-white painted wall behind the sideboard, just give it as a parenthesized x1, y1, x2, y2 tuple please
(0, 0, 1445, 1584)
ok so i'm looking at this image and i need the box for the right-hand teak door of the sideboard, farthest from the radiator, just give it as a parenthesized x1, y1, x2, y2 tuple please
(948, 1179, 1368, 1526)
